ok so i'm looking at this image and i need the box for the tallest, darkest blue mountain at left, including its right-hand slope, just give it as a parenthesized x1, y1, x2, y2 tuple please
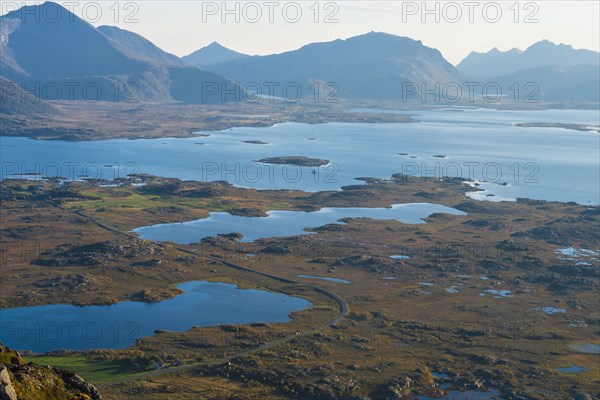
(0, 2, 236, 103)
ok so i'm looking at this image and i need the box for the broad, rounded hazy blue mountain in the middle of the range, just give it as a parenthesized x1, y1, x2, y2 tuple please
(206, 32, 464, 100)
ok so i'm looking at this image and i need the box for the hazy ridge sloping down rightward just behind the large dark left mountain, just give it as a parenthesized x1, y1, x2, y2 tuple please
(97, 25, 184, 65)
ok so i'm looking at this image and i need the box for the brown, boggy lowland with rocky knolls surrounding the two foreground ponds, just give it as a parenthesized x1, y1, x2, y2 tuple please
(0, 175, 600, 399)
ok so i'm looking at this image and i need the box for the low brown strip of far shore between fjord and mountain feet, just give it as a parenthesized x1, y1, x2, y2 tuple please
(0, 100, 598, 142)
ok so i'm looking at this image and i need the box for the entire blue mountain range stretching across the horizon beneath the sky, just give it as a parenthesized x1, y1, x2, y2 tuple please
(0, 2, 600, 114)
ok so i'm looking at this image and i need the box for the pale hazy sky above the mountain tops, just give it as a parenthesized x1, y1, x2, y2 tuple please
(5, 0, 600, 64)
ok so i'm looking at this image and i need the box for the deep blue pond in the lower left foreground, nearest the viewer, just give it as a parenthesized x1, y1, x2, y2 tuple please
(0, 281, 311, 353)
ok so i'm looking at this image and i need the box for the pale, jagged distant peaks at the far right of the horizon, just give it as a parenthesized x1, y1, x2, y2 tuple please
(457, 40, 600, 79)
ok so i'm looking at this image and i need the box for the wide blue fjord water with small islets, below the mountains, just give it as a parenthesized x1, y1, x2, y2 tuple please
(0, 109, 600, 205)
